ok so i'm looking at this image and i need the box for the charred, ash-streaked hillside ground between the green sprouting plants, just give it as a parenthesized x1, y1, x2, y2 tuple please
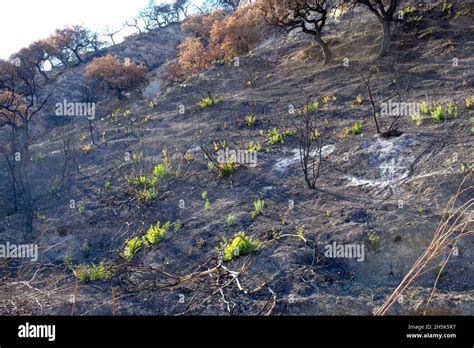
(0, 4, 474, 315)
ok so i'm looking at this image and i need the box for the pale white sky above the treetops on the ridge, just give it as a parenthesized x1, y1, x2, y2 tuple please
(0, 0, 202, 59)
